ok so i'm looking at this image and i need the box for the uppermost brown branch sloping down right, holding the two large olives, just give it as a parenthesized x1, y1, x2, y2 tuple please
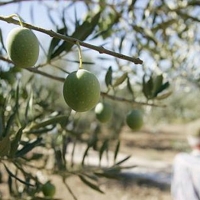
(0, 15, 143, 64)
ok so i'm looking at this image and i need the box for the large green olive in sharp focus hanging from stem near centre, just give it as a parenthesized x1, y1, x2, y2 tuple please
(63, 69, 100, 112)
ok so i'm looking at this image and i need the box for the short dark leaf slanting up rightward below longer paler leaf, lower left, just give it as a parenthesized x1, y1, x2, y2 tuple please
(15, 138, 42, 157)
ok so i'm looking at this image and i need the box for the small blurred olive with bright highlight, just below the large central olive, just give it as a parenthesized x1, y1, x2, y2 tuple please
(95, 102, 113, 123)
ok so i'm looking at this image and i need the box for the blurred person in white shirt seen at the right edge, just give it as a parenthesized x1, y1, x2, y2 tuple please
(171, 123, 200, 200)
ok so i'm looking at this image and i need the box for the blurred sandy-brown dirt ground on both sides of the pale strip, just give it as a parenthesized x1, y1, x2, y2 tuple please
(0, 122, 189, 200)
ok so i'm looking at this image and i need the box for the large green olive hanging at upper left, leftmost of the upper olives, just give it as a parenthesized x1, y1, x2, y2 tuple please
(6, 27, 39, 68)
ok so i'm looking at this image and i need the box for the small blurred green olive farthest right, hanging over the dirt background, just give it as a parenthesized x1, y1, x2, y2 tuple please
(126, 109, 143, 130)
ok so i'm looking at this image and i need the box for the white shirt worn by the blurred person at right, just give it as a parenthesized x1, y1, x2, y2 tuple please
(171, 151, 200, 200)
